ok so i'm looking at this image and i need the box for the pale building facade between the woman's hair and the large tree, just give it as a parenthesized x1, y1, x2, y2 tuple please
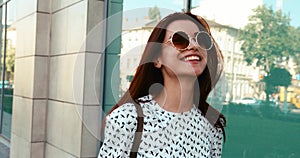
(209, 21, 260, 102)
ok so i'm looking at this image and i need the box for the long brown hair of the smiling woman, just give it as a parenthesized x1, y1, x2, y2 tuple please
(109, 13, 226, 138)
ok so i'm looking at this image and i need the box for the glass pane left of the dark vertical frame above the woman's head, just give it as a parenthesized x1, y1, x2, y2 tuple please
(120, 3, 183, 97)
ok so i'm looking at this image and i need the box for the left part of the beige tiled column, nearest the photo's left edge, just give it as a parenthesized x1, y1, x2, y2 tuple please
(10, 0, 50, 158)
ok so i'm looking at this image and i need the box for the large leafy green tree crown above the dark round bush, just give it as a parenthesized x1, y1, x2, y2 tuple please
(239, 6, 294, 69)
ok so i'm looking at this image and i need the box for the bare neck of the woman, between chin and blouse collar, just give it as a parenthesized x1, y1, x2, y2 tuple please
(155, 77, 195, 113)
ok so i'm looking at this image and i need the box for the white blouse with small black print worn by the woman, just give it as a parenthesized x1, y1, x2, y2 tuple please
(98, 95, 223, 158)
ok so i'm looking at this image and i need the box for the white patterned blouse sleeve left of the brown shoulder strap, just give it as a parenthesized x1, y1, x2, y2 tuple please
(98, 104, 137, 158)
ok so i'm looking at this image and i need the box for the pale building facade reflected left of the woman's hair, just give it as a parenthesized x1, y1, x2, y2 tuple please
(120, 18, 157, 94)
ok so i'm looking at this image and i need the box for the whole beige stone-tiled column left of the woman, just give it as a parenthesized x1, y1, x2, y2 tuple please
(10, 0, 104, 158)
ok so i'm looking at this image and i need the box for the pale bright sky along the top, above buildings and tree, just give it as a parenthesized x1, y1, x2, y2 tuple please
(123, 0, 300, 27)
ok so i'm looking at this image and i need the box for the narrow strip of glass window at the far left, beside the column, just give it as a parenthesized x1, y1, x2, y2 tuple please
(0, 1, 16, 139)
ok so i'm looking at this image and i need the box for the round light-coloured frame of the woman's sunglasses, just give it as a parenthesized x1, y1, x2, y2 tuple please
(164, 31, 214, 51)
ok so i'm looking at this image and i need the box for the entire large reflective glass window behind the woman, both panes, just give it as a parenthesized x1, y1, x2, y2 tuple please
(103, 0, 300, 158)
